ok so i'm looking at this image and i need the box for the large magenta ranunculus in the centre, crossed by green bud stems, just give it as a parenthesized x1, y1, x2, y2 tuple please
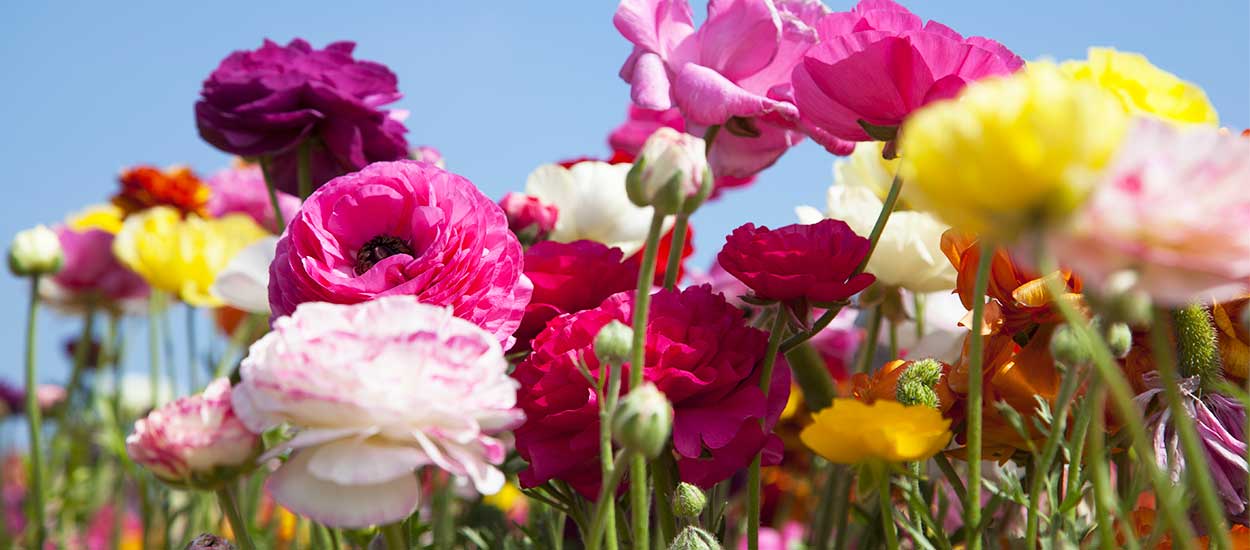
(513, 286, 790, 498)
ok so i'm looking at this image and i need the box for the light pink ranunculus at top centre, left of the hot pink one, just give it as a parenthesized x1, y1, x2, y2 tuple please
(613, 0, 826, 178)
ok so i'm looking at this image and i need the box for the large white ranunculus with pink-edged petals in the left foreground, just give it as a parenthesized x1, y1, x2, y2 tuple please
(234, 296, 523, 528)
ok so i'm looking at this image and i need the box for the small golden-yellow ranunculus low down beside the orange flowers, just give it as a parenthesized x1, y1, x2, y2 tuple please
(799, 399, 950, 464)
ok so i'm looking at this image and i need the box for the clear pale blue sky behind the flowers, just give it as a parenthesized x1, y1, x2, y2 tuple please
(0, 0, 1250, 381)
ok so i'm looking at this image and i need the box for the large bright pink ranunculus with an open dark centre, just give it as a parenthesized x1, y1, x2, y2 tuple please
(269, 160, 533, 348)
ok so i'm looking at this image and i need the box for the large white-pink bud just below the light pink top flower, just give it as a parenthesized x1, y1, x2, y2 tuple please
(625, 126, 711, 214)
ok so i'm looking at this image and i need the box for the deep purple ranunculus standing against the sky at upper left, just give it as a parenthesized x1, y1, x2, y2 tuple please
(195, 39, 408, 193)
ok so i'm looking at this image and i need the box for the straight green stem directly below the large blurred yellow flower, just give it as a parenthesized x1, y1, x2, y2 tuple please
(964, 247, 994, 550)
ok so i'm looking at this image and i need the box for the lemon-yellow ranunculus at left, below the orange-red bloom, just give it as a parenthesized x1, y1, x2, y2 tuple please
(113, 206, 269, 306)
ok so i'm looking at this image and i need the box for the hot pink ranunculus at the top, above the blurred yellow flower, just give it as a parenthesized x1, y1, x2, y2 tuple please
(793, 0, 1024, 155)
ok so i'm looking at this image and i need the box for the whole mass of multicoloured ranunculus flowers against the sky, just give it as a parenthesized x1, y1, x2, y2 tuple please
(10, 0, 1250, 550)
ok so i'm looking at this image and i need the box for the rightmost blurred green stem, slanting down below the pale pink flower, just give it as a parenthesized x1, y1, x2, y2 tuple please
(1145, 311, 1233, 549)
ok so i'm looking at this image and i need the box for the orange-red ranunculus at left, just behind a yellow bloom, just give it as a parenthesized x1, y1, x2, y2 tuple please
(113, 166, 210, 216)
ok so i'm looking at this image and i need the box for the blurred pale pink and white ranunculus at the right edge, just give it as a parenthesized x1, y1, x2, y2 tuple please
(1049, 119, 1250, 305)
